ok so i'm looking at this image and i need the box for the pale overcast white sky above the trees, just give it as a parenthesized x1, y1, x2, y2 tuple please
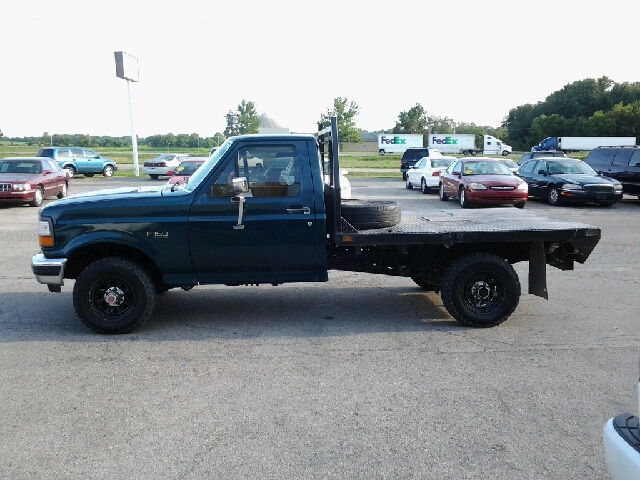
(0, 0, 640, 137)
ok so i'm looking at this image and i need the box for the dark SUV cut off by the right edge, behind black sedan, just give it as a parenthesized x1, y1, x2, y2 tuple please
(584, 146, 640, 198)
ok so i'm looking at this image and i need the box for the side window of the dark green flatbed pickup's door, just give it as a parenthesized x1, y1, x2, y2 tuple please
(211, 145, 301, 197)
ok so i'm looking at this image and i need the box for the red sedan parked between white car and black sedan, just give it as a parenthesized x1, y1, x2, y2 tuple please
(439, 157, 529, 208)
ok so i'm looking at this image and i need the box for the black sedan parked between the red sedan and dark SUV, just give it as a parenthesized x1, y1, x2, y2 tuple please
(519, 157, 622, 207)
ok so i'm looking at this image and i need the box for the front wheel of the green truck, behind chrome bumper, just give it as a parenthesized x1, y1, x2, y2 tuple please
(73, 257, 156, 334)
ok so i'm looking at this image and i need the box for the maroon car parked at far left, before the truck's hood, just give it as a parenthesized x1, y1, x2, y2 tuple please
(0, 157, 69, 207)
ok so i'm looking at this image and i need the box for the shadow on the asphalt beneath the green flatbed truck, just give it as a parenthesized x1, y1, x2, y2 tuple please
(0, 284, 466, 343)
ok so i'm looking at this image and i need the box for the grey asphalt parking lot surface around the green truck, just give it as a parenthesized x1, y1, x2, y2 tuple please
(0, 177, 640, 479)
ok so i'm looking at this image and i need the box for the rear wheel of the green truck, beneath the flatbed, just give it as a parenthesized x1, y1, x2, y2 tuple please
(441, 253, 520, 328)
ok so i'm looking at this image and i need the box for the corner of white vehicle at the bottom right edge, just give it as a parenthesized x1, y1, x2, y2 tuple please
(602, 413, 640, 480)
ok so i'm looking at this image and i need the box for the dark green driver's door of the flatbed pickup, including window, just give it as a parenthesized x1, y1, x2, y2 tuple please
(189, 141, 326, 283)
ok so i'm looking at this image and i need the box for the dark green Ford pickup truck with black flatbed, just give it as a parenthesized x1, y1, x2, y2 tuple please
(31, 118, 601, 333)
